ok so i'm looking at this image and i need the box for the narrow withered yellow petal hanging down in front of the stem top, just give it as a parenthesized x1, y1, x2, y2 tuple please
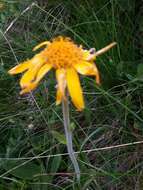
(56, 69, 66, 104)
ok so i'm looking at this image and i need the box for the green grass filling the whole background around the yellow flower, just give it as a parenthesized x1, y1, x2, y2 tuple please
(0, 0, 143, 190)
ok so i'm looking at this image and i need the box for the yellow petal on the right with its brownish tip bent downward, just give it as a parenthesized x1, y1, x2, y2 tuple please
(74, 61, 100, 84)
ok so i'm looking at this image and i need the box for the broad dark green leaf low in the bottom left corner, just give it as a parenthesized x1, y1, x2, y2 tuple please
(3, 160, 41, 180)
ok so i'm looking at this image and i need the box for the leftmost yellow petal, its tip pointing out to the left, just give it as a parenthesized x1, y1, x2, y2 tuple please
(8, 61, 32, 75)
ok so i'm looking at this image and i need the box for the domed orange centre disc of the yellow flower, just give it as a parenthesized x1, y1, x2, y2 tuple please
(44, 36, 83, 69)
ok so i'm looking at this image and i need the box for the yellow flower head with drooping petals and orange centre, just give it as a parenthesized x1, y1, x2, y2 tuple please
(9, 36, 100, 111)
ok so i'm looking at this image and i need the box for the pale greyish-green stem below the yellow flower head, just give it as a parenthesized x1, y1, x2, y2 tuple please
(62, 97, 80, 181)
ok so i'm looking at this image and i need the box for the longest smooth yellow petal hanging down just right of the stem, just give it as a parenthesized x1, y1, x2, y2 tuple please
(66, 68, 84, 111)
